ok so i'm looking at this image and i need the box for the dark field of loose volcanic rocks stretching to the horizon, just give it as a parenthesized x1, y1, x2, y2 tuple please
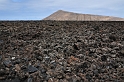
(0, 21, 124, 82)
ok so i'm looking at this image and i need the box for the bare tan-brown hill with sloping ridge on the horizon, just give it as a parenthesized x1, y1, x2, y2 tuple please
(43, 10, 124, 21)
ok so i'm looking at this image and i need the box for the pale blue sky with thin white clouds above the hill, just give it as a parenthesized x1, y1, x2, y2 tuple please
(0, 0, 124, 20)
